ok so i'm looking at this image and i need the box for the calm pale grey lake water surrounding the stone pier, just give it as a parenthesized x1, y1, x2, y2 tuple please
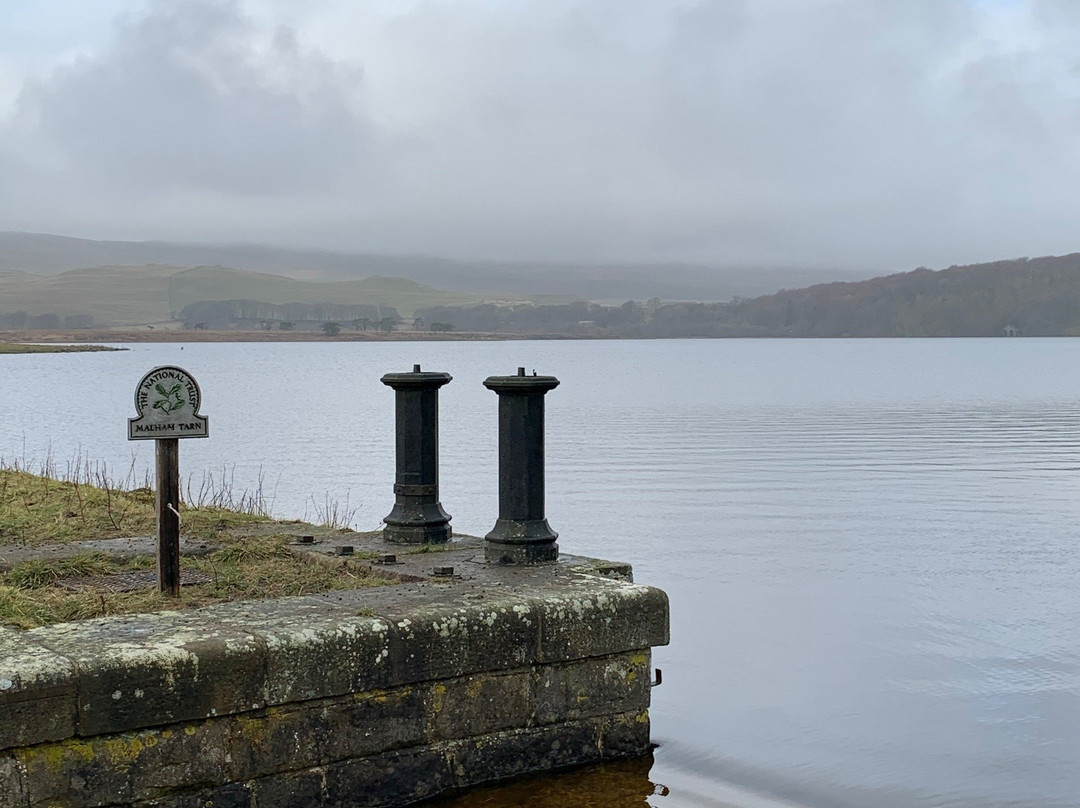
(0, 339, 1080, 808)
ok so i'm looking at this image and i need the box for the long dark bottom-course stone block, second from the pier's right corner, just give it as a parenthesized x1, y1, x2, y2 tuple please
(447, 721, 600, 787)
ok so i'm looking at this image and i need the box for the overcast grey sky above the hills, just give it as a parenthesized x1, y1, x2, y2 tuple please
(0, 0, 1080, 271)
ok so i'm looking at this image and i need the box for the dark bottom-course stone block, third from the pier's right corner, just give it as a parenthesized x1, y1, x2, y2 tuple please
(324, 745, 454, 808)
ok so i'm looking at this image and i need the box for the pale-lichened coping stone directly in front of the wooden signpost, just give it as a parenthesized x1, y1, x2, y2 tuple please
(27, 610, 266, 737)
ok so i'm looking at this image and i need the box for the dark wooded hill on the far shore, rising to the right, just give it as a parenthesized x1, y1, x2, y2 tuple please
(419, 253, 1080, 337)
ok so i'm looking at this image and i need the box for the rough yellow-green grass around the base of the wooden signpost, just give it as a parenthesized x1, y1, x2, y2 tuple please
(0, 467, 388, 629)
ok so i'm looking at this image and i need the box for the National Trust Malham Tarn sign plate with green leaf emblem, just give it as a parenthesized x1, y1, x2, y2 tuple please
(127, 365, 210, 441)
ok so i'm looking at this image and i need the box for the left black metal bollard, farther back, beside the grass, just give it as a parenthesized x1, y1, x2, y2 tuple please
(382, 365, 453, 544)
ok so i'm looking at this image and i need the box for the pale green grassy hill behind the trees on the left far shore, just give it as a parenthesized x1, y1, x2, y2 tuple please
(0, 265, 521, 328)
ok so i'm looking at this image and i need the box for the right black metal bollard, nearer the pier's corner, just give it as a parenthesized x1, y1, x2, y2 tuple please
(484, 367, 558, 564)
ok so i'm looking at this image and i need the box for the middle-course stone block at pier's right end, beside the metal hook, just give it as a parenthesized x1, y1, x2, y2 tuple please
(534, 648, 651, 725)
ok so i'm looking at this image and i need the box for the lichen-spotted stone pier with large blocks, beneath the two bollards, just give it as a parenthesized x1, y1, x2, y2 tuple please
(0, 535, 667, 808)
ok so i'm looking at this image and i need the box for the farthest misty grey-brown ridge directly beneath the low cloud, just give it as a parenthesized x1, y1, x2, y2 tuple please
(0, 232, 870, 300)
